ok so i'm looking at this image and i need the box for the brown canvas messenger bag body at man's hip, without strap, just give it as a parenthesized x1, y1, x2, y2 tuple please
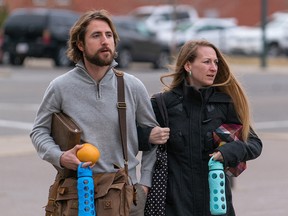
(45, 165, 135, 216)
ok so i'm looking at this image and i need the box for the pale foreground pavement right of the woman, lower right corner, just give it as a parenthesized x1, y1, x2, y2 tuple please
(234, 133, 288, 216)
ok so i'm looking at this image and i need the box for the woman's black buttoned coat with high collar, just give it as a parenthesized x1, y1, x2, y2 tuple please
(152, 82, 262, 216)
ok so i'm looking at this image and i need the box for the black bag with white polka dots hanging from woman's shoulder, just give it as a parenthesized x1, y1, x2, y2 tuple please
(144, 93, 169, 216)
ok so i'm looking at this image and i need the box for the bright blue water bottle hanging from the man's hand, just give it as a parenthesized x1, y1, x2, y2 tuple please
(77, 163, 96, 216)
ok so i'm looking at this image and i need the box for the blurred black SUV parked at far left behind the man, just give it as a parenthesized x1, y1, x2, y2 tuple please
(3, 8, 80, 66)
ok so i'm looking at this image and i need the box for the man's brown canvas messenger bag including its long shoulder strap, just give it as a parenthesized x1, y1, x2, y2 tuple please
(45, 71, 136, 216)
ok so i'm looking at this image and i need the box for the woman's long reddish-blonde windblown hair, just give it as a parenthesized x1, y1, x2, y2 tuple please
(160, 40, 251, 141)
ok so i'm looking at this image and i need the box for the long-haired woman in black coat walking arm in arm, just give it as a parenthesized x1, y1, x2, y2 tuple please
(147, 40, 262, 216)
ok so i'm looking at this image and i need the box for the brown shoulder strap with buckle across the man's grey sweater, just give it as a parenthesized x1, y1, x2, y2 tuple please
(113, 69, 128, 174)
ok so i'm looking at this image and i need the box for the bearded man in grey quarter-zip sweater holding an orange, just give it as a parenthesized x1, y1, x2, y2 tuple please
(30, 10, 169, 215)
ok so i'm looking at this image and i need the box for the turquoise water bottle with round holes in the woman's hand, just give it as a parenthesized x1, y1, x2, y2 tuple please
(208, 157, 227, 215)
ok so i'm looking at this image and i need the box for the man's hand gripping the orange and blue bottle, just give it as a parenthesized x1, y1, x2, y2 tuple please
(60, 145, 92, 170)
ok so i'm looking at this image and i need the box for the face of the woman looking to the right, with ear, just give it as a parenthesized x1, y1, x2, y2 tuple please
(185, 46, 218, 89)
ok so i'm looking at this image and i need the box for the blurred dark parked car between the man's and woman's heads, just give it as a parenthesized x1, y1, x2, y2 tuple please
(113, 16, 170, 68)
